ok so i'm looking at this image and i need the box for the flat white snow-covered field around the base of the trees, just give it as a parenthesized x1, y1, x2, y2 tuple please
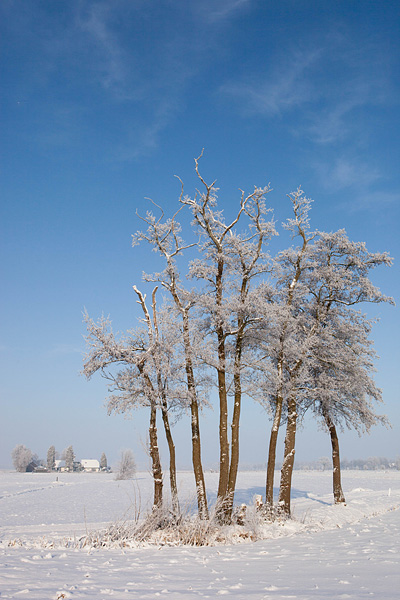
(0, 471, 400, 600)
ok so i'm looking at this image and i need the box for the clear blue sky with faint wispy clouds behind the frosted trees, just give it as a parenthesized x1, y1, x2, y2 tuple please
(0, 0, 400, 467)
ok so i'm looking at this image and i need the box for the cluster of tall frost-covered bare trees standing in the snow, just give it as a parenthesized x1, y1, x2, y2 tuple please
(84, 159, 393, 523)
